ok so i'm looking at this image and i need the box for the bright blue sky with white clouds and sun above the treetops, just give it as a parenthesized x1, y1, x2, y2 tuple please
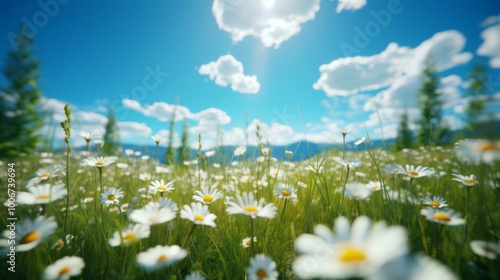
(0, 0, 500, 148)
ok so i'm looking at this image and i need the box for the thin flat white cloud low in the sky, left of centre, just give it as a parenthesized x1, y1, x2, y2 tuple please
(122, 99, 192, 122)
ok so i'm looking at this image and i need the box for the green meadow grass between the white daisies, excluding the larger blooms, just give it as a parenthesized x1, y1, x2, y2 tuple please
(0, 141, 500, 279)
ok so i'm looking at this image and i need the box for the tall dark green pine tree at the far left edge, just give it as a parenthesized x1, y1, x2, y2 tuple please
(0, 25, 43, 157)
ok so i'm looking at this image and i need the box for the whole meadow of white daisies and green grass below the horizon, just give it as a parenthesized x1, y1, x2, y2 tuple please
(0, 131, 500, 280)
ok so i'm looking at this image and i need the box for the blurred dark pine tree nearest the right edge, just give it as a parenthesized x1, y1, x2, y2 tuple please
(465, 64, 488, 131)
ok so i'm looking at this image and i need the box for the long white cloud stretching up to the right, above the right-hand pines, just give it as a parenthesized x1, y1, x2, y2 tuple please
(313, 30, 472, 96)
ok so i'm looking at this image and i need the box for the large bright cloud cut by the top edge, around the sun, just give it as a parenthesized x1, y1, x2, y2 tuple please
(212, 0, 320, 48)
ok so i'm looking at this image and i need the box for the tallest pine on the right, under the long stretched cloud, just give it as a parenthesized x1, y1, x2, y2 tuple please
(417, 59, 448, 146)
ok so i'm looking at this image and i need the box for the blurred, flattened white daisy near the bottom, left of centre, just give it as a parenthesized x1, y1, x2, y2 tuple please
(137, 245, 187, 272)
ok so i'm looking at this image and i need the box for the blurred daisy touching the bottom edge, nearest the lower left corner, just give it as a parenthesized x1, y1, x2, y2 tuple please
(43, 256, 85, 280)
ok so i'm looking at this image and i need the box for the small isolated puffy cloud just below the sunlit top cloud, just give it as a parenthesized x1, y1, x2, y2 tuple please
(198, 54, 260, 94)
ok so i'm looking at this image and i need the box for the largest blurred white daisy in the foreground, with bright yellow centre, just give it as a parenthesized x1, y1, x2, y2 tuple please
(292, 216, 408, 279)
